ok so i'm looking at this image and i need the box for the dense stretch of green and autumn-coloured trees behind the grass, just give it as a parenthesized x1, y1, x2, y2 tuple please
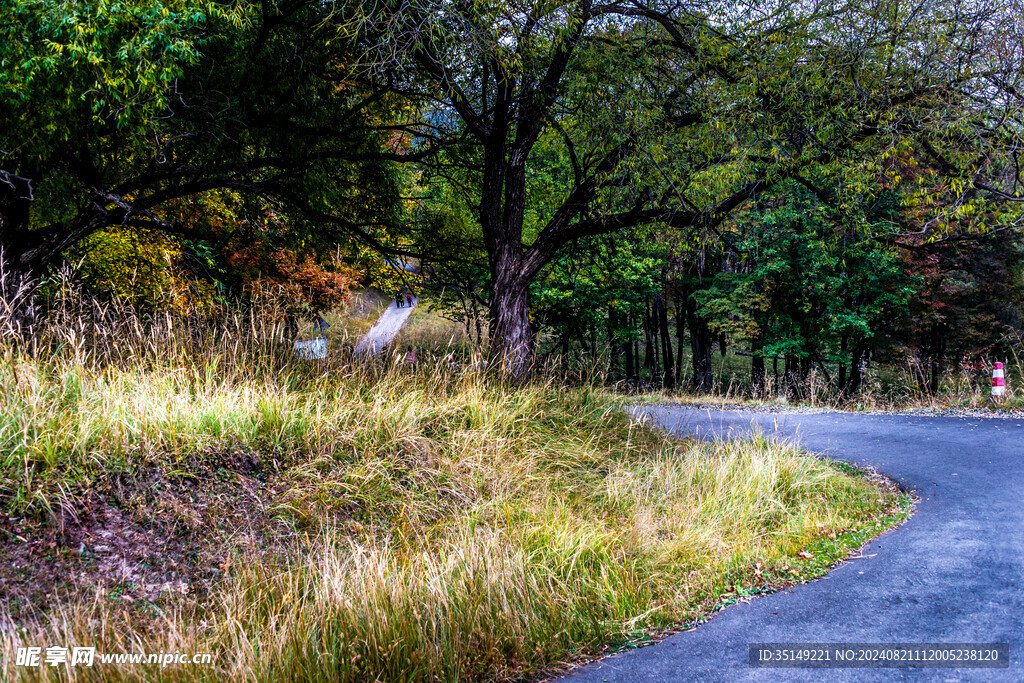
(0, 0, 1024, 394)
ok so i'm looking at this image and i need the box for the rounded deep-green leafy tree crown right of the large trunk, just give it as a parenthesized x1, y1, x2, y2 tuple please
(694, 187, 922, 364)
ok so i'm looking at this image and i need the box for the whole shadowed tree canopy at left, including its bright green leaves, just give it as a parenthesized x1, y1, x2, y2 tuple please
(0, 0, 408, 294)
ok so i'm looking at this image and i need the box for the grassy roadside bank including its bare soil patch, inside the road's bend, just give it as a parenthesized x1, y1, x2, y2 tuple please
(0, 333, 906, 681)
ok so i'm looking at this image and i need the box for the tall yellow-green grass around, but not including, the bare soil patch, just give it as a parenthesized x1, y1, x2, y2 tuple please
(0, 274, 897, 681)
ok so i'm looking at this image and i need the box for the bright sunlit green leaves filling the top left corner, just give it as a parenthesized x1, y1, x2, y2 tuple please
(0, 0, 242, 214)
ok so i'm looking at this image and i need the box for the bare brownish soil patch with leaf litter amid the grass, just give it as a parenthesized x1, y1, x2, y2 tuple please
(0, 453, 295, 615)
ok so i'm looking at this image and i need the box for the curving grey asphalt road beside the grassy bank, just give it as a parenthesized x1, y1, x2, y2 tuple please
(568, 408, 1024, 683)
